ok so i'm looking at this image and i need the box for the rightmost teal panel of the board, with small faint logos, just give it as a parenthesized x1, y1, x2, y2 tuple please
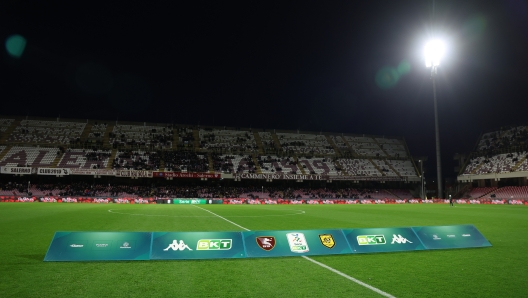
(413, 225, 491, 249)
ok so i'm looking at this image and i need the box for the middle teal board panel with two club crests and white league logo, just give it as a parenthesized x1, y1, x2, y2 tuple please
(242, 230, 352, 258)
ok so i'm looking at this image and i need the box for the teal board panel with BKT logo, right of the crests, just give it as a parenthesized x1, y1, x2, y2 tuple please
(343, 228, 425, 253)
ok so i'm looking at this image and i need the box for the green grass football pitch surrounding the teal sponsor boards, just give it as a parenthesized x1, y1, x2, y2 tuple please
(0, 203, 528, 297)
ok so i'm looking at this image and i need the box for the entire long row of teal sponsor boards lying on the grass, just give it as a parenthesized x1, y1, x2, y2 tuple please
(44, 225, 491, 261)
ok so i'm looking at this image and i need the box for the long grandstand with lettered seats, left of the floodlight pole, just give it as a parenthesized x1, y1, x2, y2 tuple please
(0, 117, 450, 199)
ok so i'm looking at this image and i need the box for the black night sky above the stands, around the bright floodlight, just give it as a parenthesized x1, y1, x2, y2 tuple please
(0, 0, 528, 177)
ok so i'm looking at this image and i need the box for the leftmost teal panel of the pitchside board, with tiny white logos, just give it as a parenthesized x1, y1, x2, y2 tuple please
(44, 232, 152, 261)
